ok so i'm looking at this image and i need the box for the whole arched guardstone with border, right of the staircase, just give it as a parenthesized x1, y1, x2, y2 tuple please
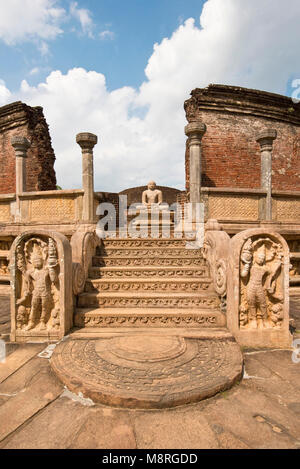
(227, 228, 292, 347)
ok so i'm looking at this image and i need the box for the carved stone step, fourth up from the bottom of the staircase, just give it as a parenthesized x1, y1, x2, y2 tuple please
(89, 266, 209, 279)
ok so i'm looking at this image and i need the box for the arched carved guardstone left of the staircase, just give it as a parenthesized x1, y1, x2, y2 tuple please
(10, 230, 73, 342)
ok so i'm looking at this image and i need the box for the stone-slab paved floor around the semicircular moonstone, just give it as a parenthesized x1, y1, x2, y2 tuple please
(0, 291, 300, 449)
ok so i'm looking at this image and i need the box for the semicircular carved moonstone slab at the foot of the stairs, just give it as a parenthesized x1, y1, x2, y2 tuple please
(51, 334, 243, 409)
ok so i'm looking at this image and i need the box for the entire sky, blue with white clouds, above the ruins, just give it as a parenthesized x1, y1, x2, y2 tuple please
(0, 0, 300, 191)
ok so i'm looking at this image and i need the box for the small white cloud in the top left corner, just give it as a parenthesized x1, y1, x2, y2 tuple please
(0, 0, 66, 45)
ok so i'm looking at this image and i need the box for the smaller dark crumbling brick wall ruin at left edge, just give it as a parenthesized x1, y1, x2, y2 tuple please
(0, 101, 56, 194)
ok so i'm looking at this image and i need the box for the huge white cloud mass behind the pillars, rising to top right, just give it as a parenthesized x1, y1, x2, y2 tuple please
(0, 0, 300, 191)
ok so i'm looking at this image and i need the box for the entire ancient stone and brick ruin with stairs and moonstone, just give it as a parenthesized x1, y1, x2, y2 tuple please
(0, 85, 300, 408)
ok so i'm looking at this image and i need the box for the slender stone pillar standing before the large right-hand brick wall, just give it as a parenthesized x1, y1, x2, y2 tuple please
(256, 129, 277, 221)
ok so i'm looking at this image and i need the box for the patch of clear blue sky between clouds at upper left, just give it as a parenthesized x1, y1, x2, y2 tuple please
(0, 0, 204, 90)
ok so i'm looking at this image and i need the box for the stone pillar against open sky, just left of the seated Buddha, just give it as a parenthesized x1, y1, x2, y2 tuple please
(76, 132, 98, 223)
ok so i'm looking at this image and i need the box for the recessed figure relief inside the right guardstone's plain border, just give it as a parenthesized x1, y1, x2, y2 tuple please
(240, 237, 283, 329)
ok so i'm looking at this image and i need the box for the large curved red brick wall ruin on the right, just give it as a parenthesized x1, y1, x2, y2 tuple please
(184, 85, 300, 191)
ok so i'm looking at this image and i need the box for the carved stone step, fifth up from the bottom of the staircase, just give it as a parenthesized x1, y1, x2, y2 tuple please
(93, 256, 206, 267)
